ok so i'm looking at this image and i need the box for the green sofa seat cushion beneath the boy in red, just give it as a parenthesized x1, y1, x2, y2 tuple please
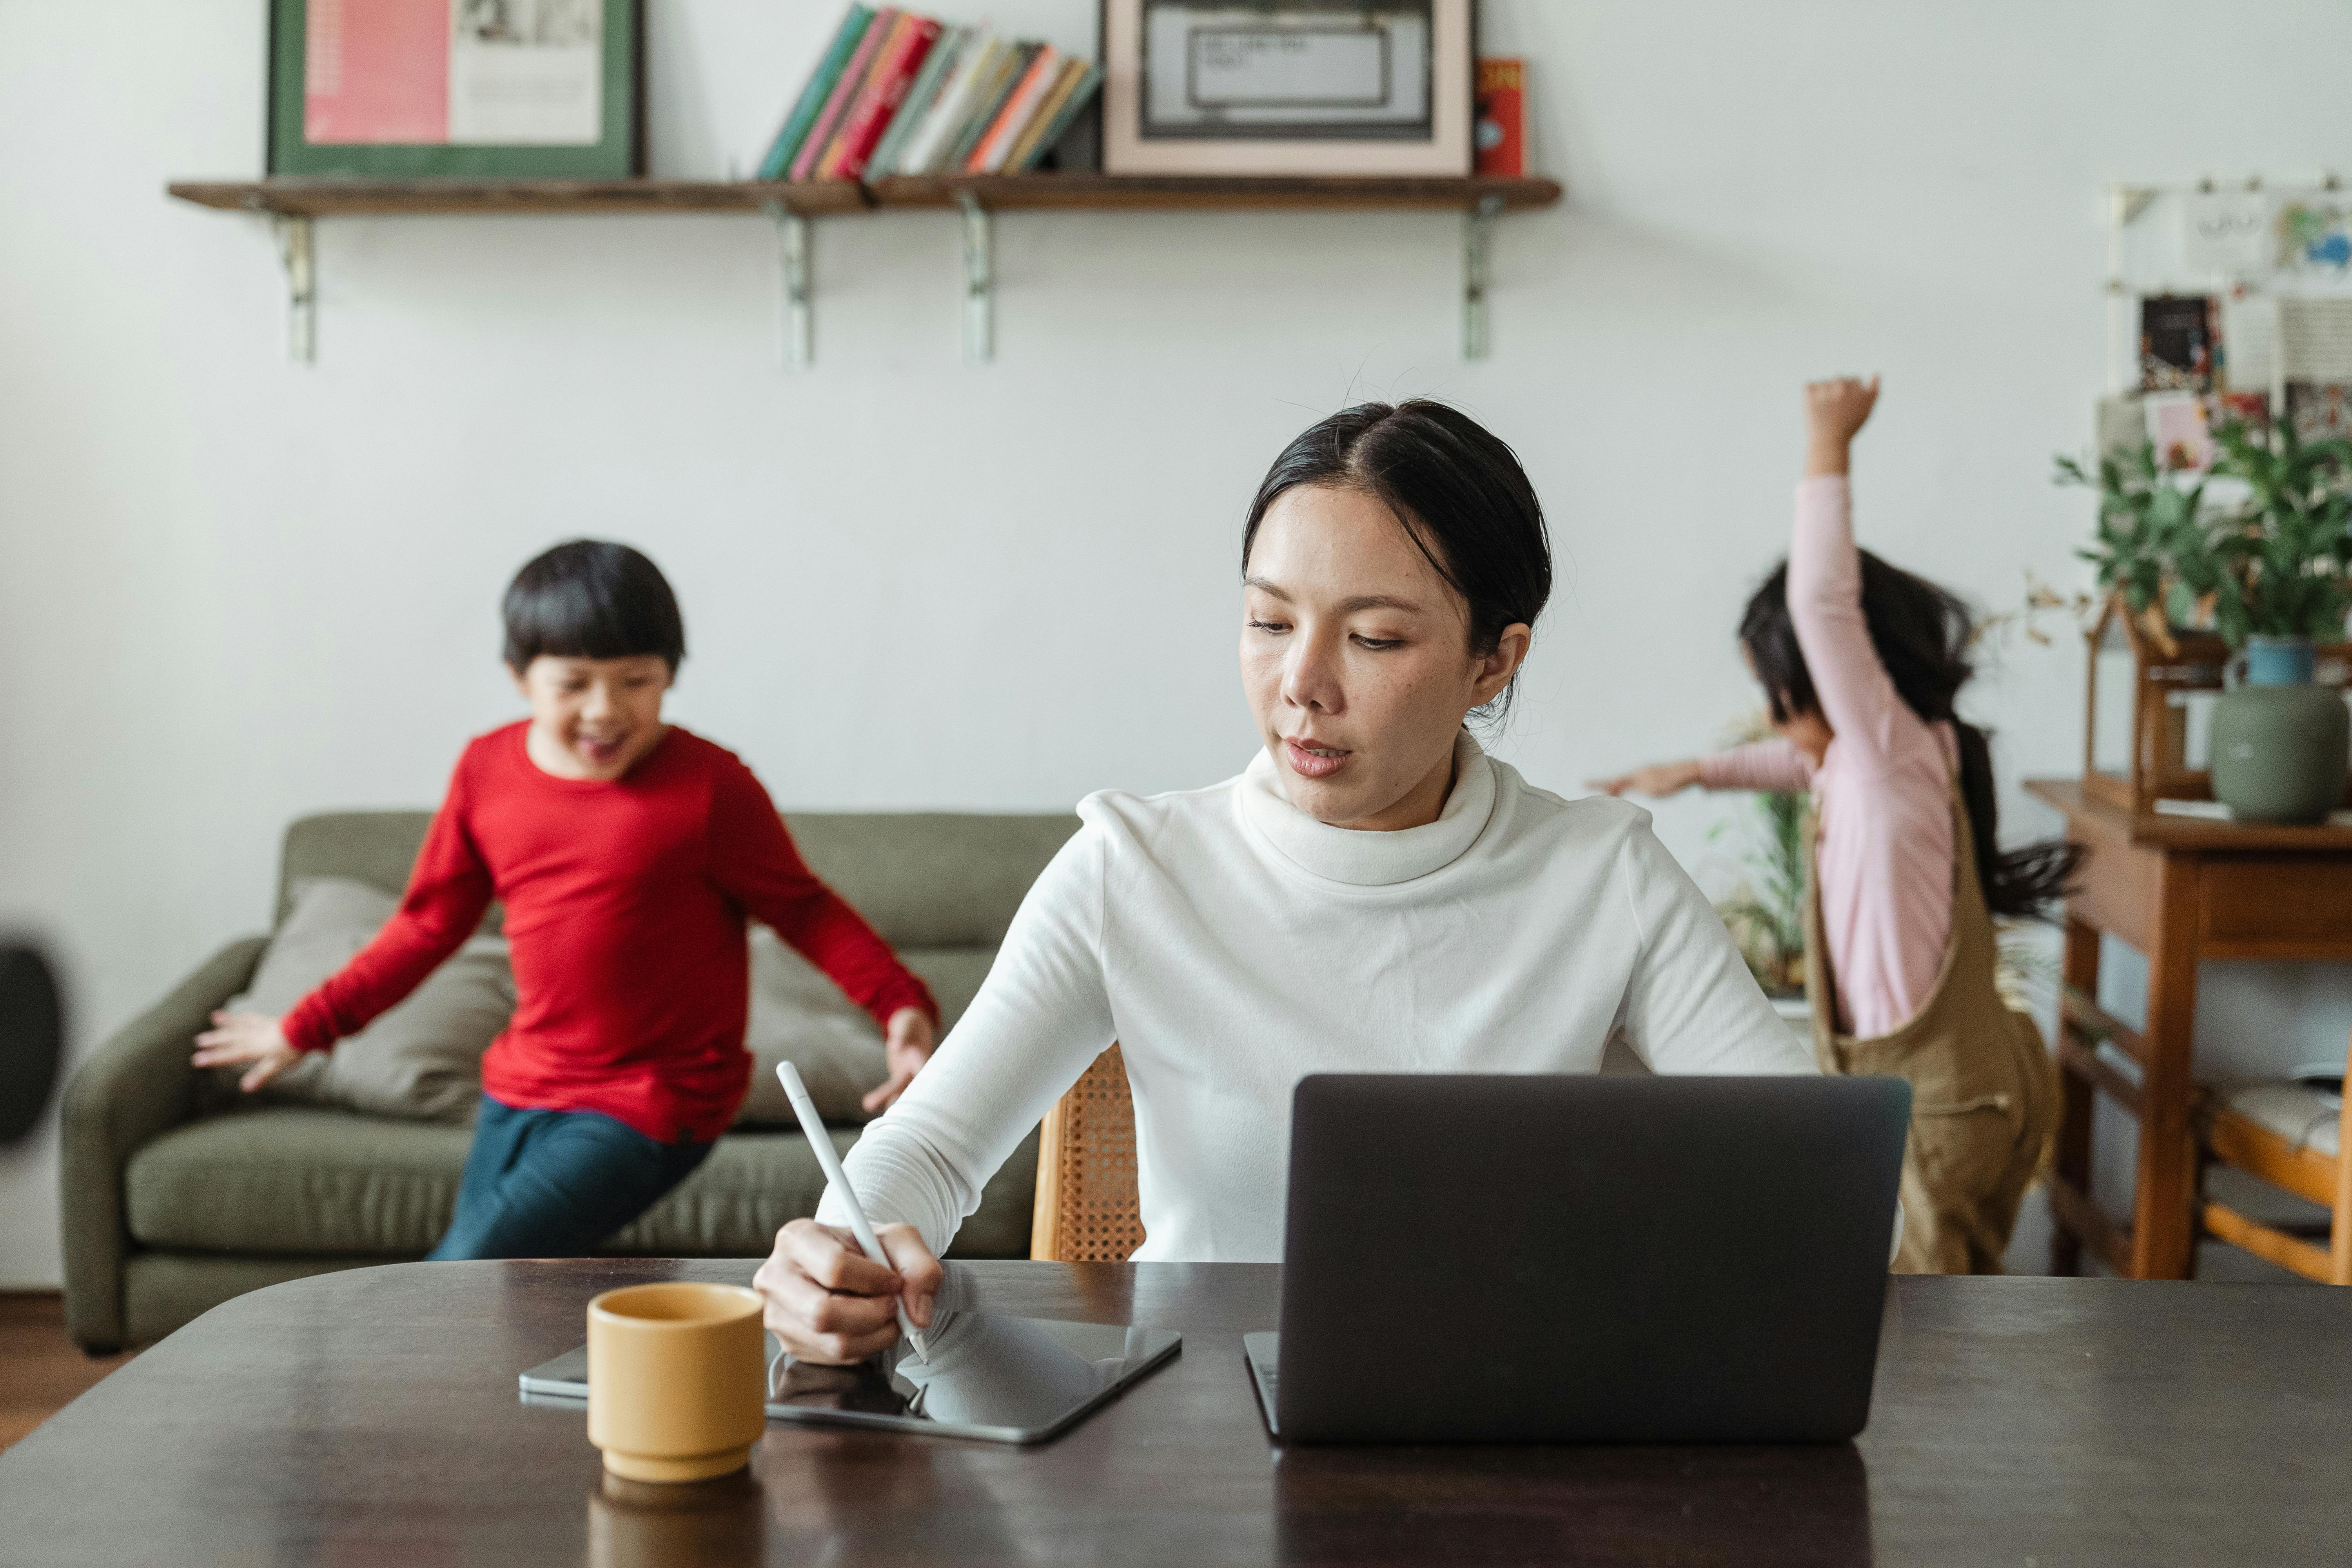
(125, 1107, 1037, 1258)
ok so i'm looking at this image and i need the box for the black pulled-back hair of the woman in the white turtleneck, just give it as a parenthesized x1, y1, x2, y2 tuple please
(1242, 397, 1552, 717)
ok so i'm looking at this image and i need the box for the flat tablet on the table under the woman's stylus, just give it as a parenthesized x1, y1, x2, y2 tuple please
(522, 1312, 1183, 1443)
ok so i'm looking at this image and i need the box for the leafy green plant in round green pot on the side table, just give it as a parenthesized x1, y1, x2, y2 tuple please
(2058, 421, 2352, 823)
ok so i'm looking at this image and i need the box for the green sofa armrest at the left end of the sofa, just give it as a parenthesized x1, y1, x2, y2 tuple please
(56, 936, 268, 1354)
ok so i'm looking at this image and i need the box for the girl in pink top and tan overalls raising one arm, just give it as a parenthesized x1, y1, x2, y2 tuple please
(1595, 376, 2079, 1274)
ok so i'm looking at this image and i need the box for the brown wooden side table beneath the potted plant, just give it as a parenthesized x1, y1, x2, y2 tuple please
(2025, 778, 2352, 1279)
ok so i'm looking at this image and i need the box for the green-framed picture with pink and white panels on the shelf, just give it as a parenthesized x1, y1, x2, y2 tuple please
(268, 0, 644, 179)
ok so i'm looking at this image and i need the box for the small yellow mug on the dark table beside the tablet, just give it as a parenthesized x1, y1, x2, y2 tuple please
(588, 1283, 767, 1481)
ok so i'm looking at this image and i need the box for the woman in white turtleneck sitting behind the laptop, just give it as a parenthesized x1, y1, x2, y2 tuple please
(755, 402, 1813, 1361)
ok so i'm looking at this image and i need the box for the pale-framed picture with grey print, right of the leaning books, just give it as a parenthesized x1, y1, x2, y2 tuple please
(1103, 0, 1477, 174)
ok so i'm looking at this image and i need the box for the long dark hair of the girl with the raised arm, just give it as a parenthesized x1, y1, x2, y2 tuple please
(1740, 550, 2084, 917)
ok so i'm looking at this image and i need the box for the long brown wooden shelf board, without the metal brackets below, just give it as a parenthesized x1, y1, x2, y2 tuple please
(167, 174, 1559, 219)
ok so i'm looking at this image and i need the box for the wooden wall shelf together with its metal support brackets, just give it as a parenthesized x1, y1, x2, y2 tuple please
(165, 174, 1559, 365)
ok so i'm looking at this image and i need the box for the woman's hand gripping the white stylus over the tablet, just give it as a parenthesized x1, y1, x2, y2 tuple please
(750, 1220, 948, 1366)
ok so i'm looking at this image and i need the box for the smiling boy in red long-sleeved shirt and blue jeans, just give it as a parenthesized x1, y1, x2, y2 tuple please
(195, 541, 938, 1258)
